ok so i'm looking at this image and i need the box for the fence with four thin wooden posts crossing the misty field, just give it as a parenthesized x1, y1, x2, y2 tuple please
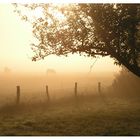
(0, 82, 107, 107)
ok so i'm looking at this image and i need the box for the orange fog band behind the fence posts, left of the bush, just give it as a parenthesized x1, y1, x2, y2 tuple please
(0, 72, 114, 103)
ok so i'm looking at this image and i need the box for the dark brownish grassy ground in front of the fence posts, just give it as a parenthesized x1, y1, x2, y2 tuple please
(0, 96, 140, 136)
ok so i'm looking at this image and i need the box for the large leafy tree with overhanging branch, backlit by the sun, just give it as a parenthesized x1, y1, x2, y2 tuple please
(13, 4, 140, 77)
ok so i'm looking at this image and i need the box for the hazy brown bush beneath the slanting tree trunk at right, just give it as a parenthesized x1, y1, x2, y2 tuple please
(111, 67, 140, 97)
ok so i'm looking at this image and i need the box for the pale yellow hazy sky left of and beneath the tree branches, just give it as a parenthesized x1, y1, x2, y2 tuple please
(0, 4, 119, 73)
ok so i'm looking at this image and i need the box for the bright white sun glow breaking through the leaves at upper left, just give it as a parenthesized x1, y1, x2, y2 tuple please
(19, 3, 72, 22)
